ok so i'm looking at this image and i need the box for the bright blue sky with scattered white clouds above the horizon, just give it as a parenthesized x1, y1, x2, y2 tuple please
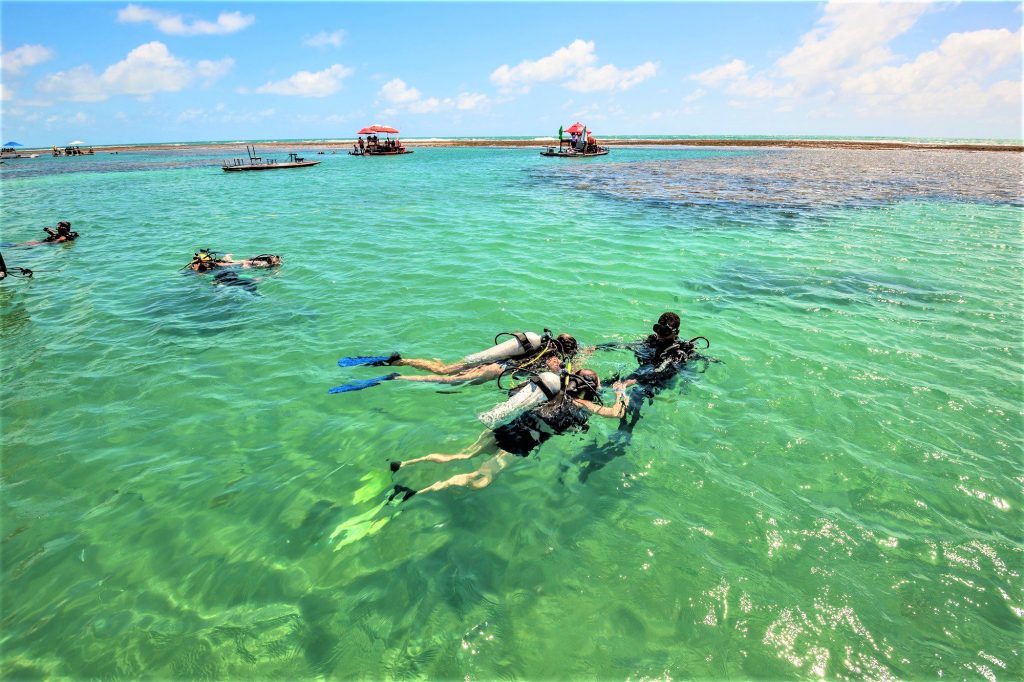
(0, 2, 1022, 145)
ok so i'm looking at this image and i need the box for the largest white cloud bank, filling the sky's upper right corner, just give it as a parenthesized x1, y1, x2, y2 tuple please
(690, 1, 1024, 126)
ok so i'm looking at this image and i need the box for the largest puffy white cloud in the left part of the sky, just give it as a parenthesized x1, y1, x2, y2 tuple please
(36, 41, 234, 101)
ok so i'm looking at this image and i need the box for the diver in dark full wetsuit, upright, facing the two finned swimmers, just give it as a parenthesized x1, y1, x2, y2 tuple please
(563, 312, 718, 483)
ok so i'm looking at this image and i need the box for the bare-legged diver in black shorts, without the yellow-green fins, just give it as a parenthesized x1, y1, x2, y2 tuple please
(388, 370, 630, 502)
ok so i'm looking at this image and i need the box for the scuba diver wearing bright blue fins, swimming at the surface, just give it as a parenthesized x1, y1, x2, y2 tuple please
(328, 329, 579, 393)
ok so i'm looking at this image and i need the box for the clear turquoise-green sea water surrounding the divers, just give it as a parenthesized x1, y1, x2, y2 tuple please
(0, 148, 1024, 680)
